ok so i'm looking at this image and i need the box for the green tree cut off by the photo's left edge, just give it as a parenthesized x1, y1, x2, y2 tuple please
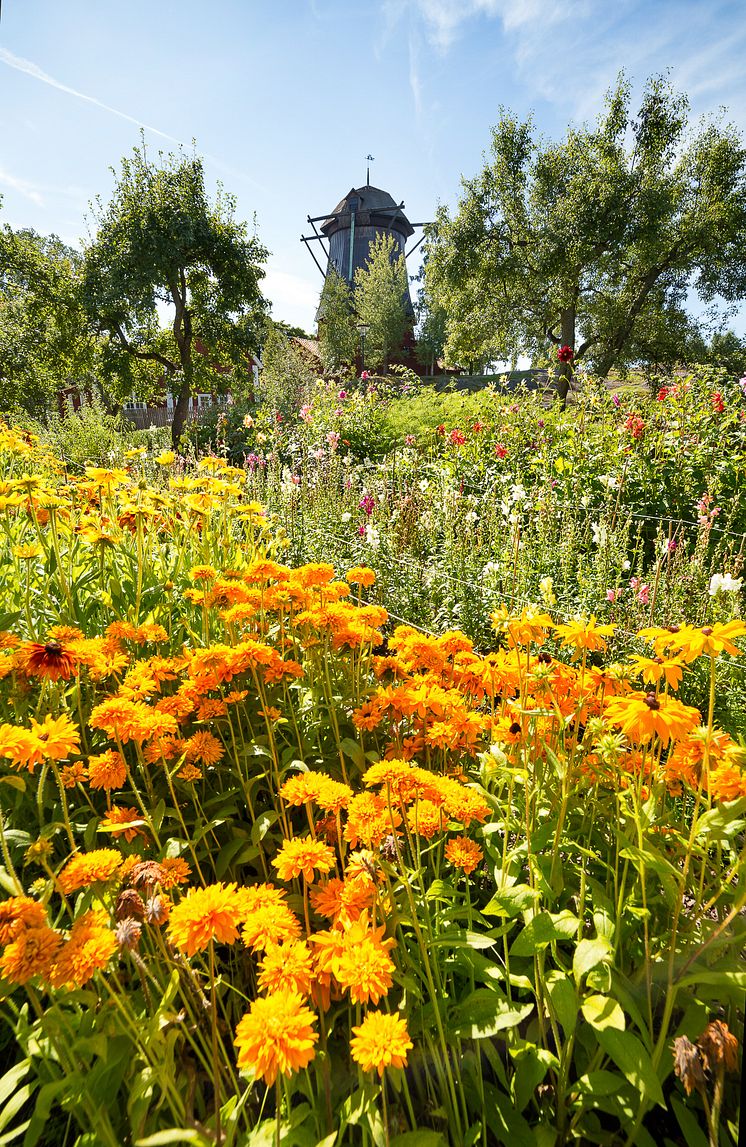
(0, 212, 96, 416)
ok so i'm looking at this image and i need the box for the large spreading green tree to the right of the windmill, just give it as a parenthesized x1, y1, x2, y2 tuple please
(427, 76, 746, 399)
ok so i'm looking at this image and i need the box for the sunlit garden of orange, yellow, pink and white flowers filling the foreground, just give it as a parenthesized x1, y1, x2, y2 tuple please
(0, 371, 746, 1147)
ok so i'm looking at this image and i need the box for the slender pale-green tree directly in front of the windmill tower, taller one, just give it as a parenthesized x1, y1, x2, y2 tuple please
(355, 234, 410, 370)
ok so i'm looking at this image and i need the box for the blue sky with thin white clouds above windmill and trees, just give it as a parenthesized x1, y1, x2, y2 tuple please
(0, 0, 746, 333)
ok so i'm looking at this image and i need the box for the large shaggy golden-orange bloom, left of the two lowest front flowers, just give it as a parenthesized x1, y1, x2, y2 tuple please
(234, 991, 318, 1086)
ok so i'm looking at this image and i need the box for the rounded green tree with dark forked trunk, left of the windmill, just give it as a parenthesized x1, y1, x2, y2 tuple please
(81, 145, 267, 445)
